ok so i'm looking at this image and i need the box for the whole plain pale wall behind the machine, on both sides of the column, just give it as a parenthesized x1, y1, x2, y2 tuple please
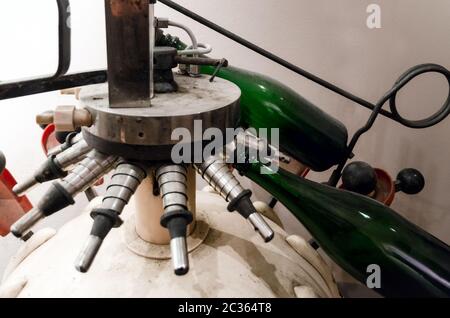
(0, 0, 450, 280)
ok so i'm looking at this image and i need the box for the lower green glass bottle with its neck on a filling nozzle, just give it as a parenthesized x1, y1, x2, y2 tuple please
(236, 164, 450, 297)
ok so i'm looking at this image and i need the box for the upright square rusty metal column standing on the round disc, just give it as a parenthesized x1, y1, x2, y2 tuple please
(105, 0, 154, 108)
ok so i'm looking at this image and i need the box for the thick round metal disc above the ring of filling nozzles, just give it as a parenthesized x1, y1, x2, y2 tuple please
(80, 75, 241, 150)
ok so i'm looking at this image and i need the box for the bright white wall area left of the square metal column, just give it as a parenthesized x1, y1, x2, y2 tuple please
(0, 0, 106, 273)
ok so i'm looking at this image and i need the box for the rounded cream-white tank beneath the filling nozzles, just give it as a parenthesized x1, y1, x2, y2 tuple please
(0, 191, 339, 298)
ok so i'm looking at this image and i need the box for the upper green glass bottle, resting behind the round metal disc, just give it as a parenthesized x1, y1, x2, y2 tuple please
(202, 66, 348, 171)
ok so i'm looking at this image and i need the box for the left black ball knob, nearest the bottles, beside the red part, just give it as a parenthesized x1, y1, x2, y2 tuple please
(342, 161, 377, 195)
